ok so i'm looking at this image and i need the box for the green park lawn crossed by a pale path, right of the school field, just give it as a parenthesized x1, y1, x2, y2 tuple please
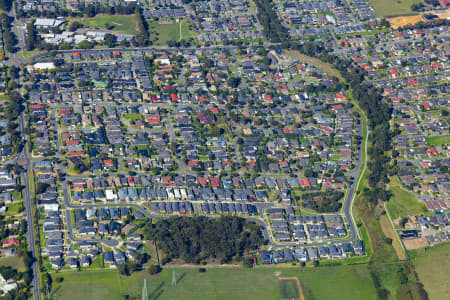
(148, 20, 192, 45)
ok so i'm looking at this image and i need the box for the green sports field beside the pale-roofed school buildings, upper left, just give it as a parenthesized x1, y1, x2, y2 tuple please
(70, 15, 138, 35)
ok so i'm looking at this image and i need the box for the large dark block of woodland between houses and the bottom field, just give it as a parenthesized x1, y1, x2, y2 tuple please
(143, 217, 264, 264)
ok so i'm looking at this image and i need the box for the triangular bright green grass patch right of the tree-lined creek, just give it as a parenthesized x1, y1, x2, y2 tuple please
(387, 177, 426, 221)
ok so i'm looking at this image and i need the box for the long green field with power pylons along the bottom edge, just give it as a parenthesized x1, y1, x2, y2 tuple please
(53, 265, 376, 300)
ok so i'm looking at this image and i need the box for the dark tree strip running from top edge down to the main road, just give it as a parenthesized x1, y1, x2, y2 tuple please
(254, 0, 289, 43)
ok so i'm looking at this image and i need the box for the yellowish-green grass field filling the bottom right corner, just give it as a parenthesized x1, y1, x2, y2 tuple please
(410, 243, 450, 300)
